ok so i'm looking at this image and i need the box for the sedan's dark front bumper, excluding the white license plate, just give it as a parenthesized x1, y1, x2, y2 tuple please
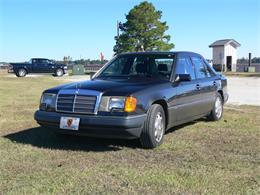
(34, 110, 146, 139)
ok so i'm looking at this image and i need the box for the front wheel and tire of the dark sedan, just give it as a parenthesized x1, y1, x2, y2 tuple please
(140, 104, 165, 149)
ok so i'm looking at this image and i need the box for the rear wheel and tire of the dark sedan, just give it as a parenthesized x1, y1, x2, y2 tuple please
(207, 93, 223, 121)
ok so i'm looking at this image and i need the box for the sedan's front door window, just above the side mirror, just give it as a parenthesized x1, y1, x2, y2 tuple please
(175, 57, 195, 80)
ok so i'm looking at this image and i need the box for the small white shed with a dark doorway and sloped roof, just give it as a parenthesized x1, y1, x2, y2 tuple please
(209, 39, 241, 72)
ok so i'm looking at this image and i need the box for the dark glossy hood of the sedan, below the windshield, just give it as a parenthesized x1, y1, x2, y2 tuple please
(45, 78, 168, 96)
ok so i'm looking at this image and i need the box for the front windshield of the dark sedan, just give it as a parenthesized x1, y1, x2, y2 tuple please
(97, 54, 174, 80)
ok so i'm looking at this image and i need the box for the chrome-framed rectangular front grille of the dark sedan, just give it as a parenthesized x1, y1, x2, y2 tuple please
(56, 94, 97, 114)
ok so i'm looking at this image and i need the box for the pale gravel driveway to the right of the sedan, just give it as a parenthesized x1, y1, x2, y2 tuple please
(227, 77, 260, 106)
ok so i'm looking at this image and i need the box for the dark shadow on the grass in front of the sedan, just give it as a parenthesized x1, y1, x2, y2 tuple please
(4, 127, 140, 152)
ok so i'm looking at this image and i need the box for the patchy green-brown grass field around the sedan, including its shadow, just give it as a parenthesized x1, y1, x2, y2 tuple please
(0, 72, 260, 194)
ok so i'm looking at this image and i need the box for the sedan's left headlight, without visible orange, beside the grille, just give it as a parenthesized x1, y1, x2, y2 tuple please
(40, 93, 57, 111)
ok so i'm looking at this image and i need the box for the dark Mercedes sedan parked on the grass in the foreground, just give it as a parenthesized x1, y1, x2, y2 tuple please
(35, 52, 228, 148)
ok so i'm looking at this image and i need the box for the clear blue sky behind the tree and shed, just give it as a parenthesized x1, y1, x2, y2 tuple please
(0, 0, 260, 62)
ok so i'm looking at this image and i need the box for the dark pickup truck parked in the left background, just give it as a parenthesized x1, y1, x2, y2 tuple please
(8, 58, 68, 77)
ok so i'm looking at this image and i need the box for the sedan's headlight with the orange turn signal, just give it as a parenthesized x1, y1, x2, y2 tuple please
(99, 96, 137, 112)
